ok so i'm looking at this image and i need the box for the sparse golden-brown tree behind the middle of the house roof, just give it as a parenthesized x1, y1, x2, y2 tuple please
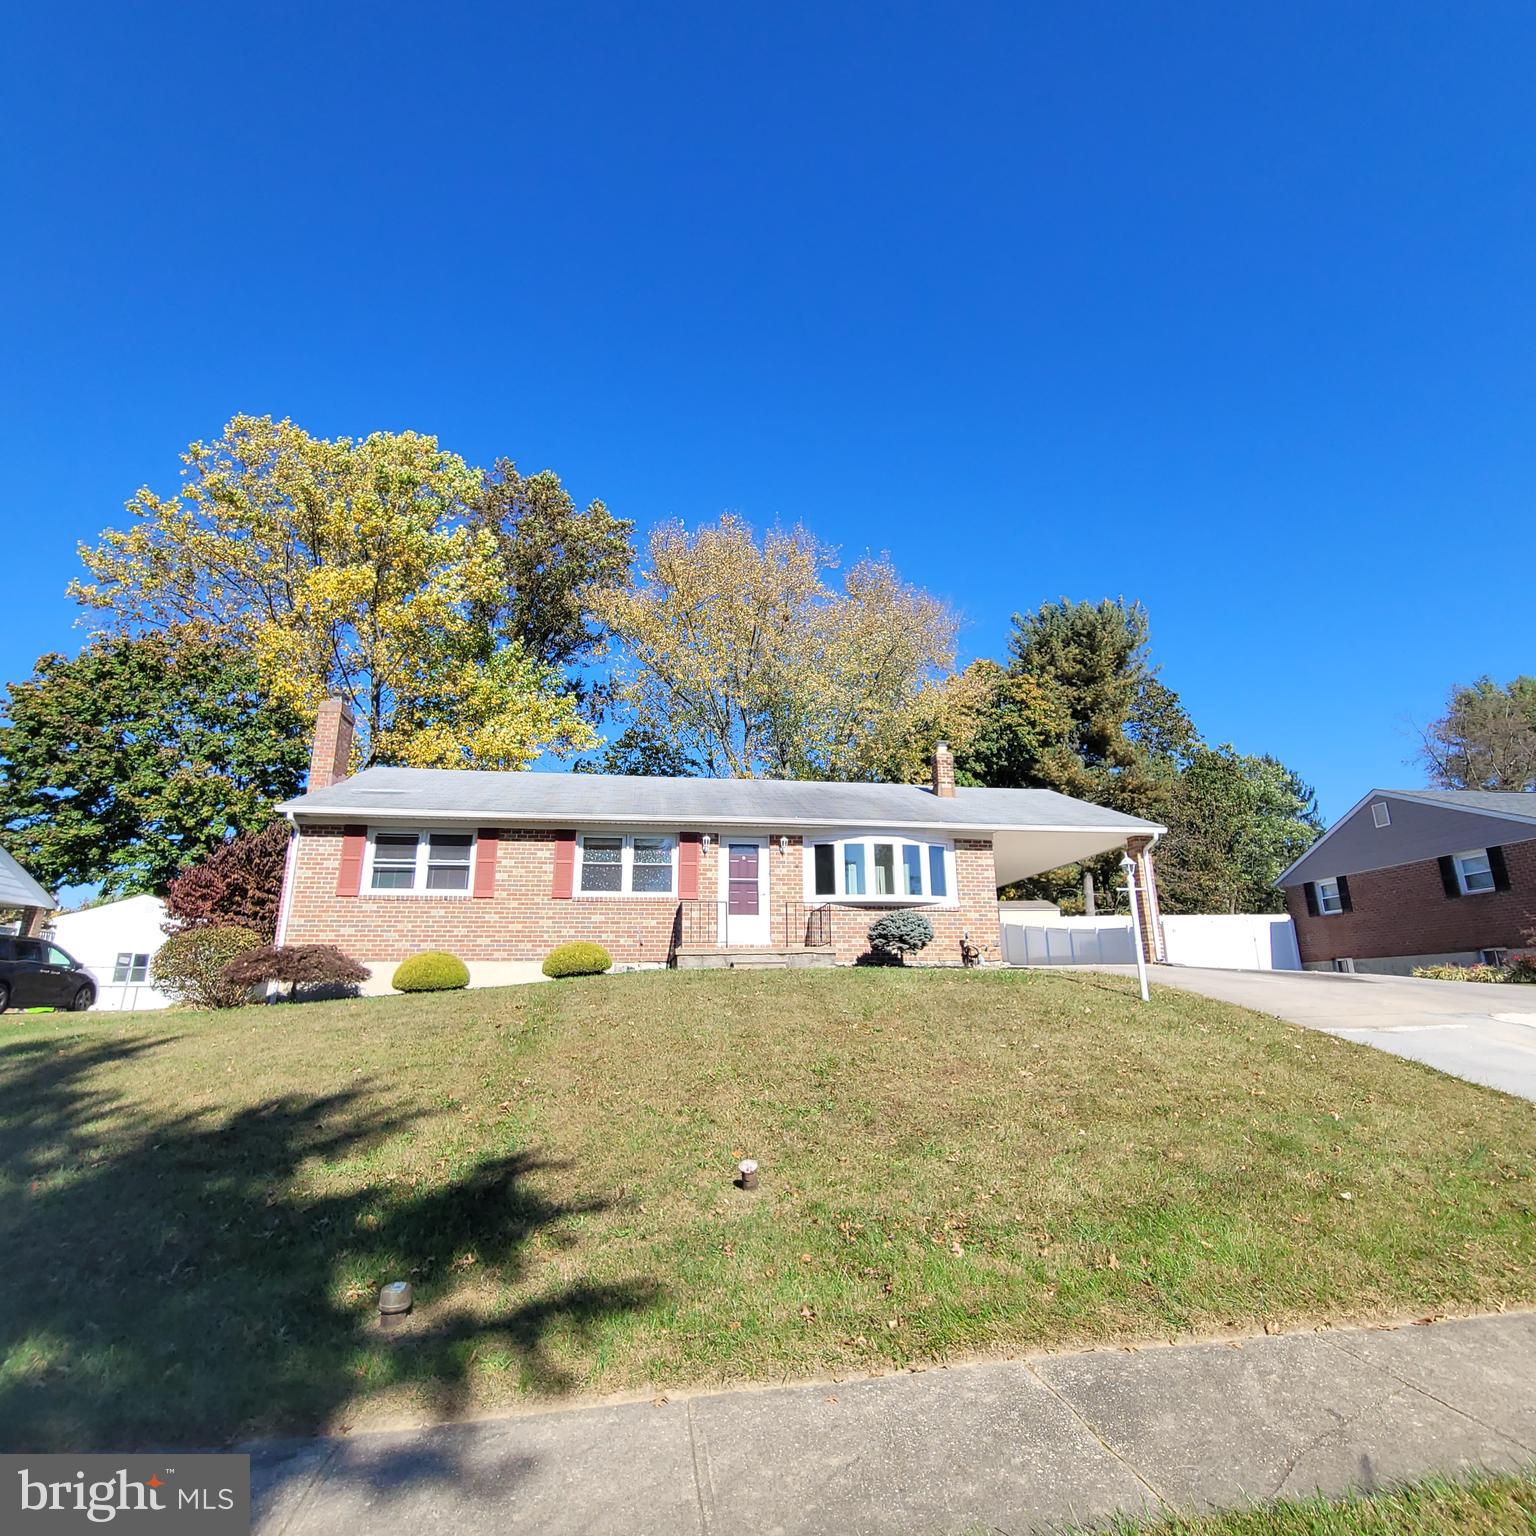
(591, 516, 957, 779)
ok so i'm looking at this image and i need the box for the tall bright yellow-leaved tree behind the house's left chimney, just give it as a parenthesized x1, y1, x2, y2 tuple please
(71, 416, 599, 768)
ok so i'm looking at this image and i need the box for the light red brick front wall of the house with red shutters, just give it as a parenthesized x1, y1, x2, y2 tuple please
(284, 826, 1000, 965)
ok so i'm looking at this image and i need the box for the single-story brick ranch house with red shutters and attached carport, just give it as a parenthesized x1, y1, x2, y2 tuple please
(278, 699, 1163, 982)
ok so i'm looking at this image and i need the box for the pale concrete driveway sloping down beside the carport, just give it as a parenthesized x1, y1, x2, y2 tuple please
(1152, 966, 1536, 1100)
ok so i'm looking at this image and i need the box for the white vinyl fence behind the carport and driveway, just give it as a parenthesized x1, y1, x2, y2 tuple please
(1001, 908, 1301, 971)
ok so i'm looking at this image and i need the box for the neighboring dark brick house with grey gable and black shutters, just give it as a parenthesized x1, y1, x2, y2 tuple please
(1275, 790, 1536, 975)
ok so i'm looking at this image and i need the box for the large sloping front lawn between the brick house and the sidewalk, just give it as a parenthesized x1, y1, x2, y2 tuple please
(0, 969, 1536, 1448)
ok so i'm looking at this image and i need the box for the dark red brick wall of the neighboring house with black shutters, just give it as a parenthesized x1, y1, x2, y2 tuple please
(1286, 840, 1536, 963)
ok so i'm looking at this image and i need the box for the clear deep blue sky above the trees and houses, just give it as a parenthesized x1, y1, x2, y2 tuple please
(0, 0, 1536, 816)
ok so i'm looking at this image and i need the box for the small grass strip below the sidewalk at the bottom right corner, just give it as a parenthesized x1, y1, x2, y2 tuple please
(1087, 1473, 1536, 1536)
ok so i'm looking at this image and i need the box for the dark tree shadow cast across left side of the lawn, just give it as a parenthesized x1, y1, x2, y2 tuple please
(0, 1035, 659, 1452)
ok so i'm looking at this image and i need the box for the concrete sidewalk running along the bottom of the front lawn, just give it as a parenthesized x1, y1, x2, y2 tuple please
(243, 1313, 1536, 1536)
